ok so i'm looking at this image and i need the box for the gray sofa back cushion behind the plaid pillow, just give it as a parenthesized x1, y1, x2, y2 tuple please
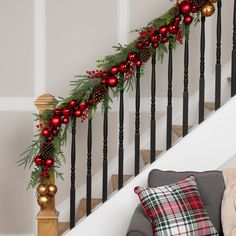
(148, 169, 225, 235)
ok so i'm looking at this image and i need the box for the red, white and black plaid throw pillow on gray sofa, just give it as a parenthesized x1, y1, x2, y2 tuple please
(134, 176, 219, 236)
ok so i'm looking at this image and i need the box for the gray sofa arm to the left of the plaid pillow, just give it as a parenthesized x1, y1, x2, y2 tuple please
(126, 205, 153, 236)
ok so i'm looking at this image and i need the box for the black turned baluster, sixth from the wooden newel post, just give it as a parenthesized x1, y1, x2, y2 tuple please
(150, 50, 156, 163)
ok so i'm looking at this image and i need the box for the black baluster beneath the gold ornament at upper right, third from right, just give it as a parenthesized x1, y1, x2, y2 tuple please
(198, 16, 206, 123)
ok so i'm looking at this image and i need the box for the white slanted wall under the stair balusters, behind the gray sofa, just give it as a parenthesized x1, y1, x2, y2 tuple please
(66, 97, 236, 236)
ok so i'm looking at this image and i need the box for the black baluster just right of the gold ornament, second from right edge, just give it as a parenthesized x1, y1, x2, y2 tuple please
(215, 0, 222, 110)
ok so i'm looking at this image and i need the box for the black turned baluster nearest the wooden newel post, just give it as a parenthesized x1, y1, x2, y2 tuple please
(70, 116, 76, 229)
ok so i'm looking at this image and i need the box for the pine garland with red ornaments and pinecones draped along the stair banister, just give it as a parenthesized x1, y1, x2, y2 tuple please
(18, 0, 217, 192)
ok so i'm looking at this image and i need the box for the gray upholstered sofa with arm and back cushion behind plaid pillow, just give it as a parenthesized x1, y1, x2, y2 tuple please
(126, 170, 225, 236)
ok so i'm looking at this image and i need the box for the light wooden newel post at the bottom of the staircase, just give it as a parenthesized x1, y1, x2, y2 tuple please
(34, 94, 59, 236)
